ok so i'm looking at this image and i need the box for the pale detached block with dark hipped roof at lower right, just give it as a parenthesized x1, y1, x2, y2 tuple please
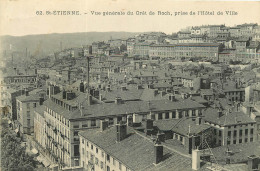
(204, 107, 257, 146)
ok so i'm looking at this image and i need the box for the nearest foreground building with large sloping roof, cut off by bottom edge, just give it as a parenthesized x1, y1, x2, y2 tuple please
(79, 122, 203, 171)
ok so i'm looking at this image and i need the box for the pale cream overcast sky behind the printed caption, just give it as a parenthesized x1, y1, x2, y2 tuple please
(0, 0, 260, 36)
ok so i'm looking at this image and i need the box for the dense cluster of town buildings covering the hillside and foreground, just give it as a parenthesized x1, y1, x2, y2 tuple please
(0, 24, 260, 171)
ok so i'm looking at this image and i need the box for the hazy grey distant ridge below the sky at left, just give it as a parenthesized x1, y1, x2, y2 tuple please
(0, 32, 140, 54)
